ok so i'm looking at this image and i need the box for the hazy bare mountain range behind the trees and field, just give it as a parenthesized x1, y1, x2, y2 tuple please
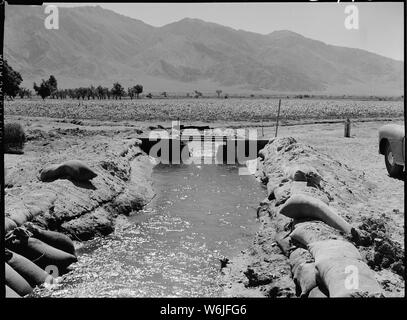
(4, 6, 404, 95)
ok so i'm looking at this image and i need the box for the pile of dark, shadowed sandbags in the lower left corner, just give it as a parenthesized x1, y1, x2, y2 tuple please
(5, 218, 77, 298)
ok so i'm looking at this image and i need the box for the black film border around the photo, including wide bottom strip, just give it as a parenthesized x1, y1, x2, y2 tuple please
(0, 0, 407, 319)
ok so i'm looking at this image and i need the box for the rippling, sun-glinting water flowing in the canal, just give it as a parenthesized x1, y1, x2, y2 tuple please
(36, 142, 265, 297)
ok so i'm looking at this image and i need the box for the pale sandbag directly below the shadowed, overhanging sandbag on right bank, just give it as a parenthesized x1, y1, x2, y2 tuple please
(290, 221, 343, 247)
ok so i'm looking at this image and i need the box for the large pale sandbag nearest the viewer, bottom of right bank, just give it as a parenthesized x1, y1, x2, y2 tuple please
(315, 257, 383, 298)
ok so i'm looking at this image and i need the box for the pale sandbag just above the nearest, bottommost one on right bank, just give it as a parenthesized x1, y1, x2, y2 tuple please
(308, 240, 362, 263)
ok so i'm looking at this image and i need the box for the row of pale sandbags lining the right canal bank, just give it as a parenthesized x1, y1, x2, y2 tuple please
(269, 170, 382, 297)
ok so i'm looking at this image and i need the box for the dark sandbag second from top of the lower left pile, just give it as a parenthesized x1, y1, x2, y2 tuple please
(6, 237, 78, 270)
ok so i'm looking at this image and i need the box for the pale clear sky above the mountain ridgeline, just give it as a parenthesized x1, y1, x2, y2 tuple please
(48, 2, 404, 60)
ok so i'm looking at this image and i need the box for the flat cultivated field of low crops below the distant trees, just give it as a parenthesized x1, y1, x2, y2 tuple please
(5, 99, 404, 122)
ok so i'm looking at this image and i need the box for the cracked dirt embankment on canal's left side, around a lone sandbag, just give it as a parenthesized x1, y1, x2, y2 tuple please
(5, 121, 154, 241)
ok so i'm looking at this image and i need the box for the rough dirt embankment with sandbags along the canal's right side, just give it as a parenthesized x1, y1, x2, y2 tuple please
(223, 138, 405, 297)
